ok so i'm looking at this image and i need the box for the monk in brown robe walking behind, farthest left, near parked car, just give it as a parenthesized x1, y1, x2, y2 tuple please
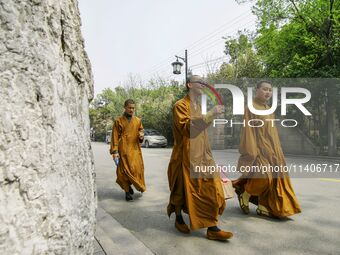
(110, 99, 146, 201)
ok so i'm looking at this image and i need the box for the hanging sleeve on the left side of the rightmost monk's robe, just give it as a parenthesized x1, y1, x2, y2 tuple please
(237, 108, 258, 170)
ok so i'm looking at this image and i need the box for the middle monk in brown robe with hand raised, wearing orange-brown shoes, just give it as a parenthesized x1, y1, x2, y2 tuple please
(167, 75, 233, 240)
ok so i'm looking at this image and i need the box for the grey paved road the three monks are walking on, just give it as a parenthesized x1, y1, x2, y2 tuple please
(92, 143, 340, 255)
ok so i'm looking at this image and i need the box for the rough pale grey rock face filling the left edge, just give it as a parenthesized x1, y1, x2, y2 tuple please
(0, 0, 96, 255)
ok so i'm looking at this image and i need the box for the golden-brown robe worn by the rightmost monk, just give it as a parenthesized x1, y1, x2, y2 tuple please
(234, 99, 301, 217)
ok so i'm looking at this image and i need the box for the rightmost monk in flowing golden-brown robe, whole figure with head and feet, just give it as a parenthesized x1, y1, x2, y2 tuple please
(233, 81, 301, 218)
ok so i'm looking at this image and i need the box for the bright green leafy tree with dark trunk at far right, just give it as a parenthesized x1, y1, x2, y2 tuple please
(239, 0, 340, 155)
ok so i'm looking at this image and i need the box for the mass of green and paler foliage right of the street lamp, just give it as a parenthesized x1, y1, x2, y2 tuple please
(209, 0, 340, 155)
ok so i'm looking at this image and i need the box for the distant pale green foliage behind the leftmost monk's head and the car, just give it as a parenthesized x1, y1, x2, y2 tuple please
(90, 79, 185, 143)
